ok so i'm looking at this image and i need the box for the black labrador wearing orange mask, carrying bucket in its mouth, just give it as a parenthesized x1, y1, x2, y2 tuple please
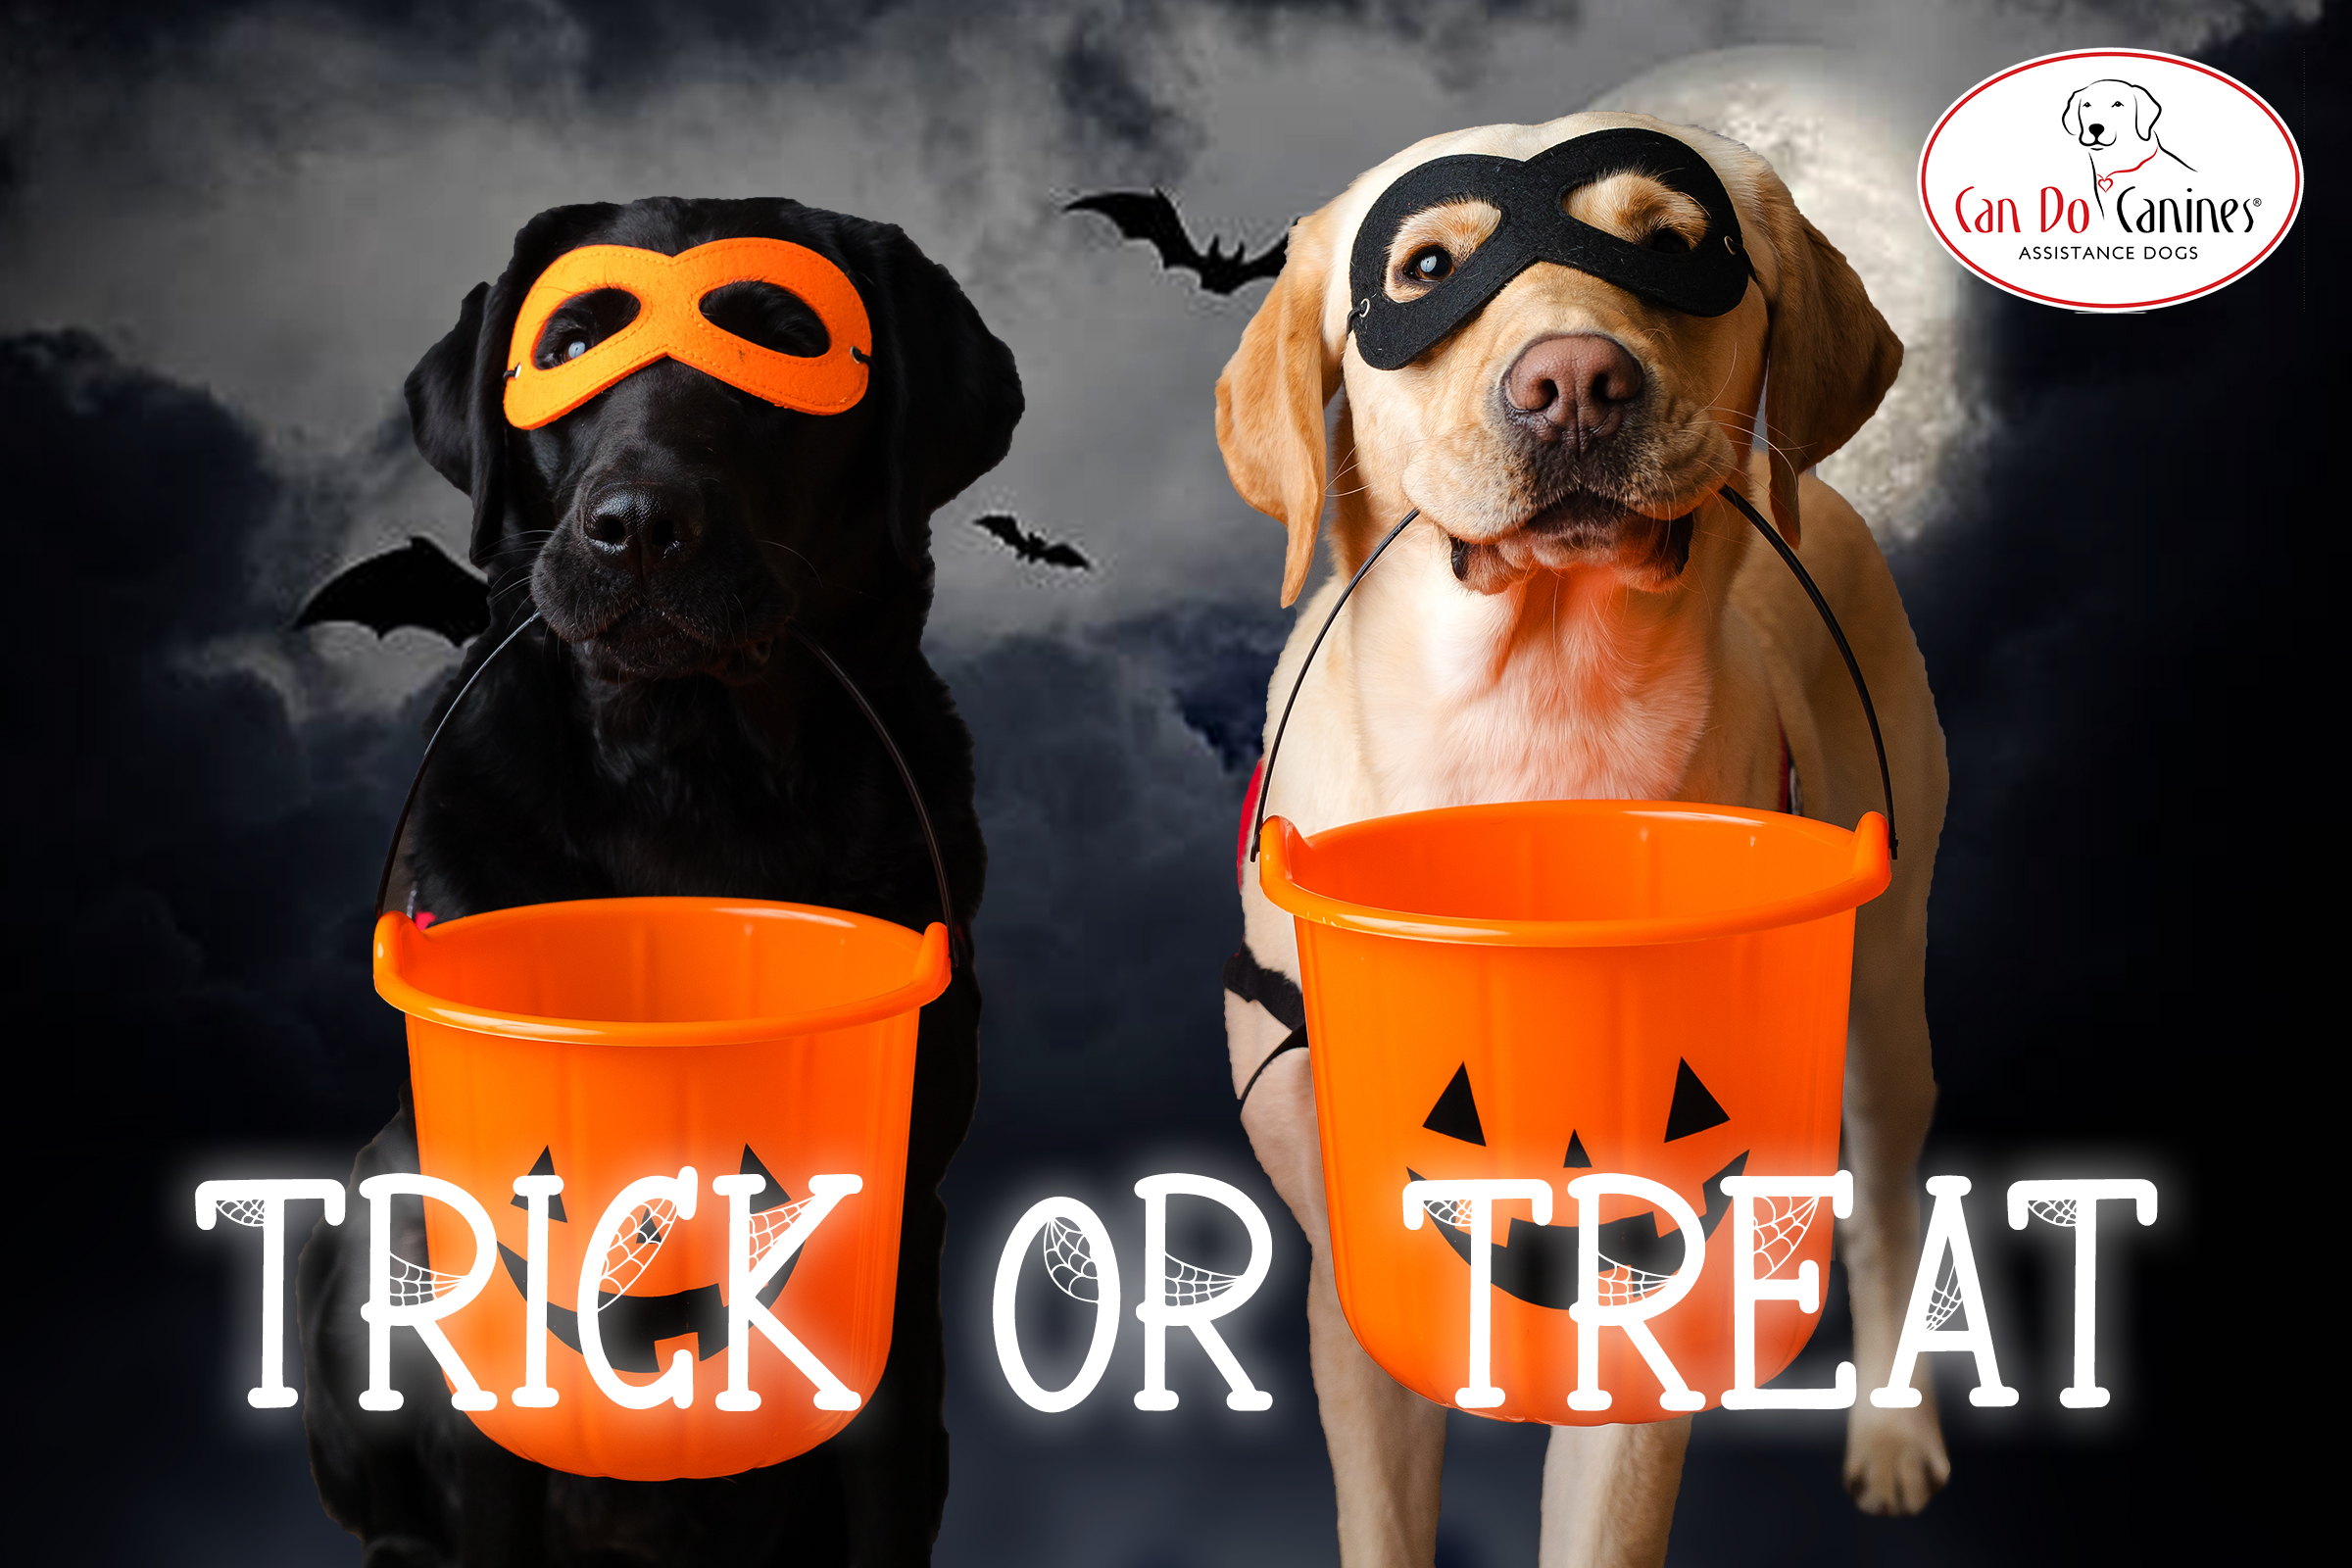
(296, 200, 1021, 1568)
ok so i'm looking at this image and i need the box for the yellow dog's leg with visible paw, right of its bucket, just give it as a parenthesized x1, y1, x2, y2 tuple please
(1839, 945, 1952, 1514)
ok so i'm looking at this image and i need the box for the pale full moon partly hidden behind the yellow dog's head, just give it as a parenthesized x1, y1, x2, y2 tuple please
(1592, 49, 1983, 546)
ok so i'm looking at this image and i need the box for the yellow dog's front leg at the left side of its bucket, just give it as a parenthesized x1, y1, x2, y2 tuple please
(1225, 992, 1446, 1568)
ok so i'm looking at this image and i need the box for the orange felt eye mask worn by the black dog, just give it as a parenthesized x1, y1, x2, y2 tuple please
(506, 240, 875, 430)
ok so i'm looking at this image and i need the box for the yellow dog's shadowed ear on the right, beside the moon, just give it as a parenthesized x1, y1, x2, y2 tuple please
(1757, 172, 1903, 546)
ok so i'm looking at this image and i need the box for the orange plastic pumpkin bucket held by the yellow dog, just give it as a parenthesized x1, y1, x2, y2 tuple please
(1260, 802, 1891, 1425)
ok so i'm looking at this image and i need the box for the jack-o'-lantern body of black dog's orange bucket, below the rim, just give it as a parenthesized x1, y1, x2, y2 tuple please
(410, 1015, 915, 1479)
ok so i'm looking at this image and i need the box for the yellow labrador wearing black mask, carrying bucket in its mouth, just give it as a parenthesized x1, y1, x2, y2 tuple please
(1216, 113, 1950, 1568)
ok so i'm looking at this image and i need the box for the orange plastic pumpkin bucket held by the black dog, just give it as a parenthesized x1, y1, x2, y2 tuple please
(374, 898, 951, 1481)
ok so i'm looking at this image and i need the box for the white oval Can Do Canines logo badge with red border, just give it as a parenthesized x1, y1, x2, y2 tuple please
(1919, 49, 2303, 311)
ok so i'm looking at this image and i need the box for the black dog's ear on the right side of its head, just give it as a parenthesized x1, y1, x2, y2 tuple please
(860, 228, 1023, 573)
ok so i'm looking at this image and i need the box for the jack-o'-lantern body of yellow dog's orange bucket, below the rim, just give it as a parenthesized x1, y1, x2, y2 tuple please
(1307, 931, 1844, 1425)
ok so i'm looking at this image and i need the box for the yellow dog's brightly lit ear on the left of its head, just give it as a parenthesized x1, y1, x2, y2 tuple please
(1216, 212, 1339, 604)
